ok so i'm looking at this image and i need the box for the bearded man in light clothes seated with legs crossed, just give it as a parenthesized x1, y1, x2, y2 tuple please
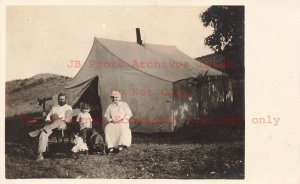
(29, 93, 72, 161)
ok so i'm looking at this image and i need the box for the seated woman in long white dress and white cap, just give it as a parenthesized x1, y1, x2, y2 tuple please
(104, 91, 132, 153)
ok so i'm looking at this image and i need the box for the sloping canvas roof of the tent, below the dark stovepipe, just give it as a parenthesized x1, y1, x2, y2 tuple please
(95, 38, 222, 82)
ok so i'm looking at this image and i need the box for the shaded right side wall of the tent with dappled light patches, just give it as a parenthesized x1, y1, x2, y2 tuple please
(173, 76, 233, 129)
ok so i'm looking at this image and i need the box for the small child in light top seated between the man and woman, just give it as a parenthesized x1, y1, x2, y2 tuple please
(76, 103, 93, 143)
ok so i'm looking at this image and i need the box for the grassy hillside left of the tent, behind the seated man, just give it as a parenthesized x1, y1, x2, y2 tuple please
(5, 73, 71, 117)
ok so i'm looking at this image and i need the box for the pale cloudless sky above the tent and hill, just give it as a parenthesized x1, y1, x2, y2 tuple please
(6, 6, 212, 81)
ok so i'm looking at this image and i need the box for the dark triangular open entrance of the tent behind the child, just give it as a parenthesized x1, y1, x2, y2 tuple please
(73, 77, 102, 130)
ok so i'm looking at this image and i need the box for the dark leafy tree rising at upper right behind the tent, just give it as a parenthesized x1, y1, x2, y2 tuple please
(200, 6, 245, 75)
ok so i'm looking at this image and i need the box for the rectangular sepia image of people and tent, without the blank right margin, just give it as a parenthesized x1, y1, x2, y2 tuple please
(5, 2, 246, 180)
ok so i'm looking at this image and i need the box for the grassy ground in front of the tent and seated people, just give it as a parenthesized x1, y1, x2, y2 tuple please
(5, 116, 244, 179)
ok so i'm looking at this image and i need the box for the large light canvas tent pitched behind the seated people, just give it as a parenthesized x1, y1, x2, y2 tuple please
(59, 38, 231, 132)
